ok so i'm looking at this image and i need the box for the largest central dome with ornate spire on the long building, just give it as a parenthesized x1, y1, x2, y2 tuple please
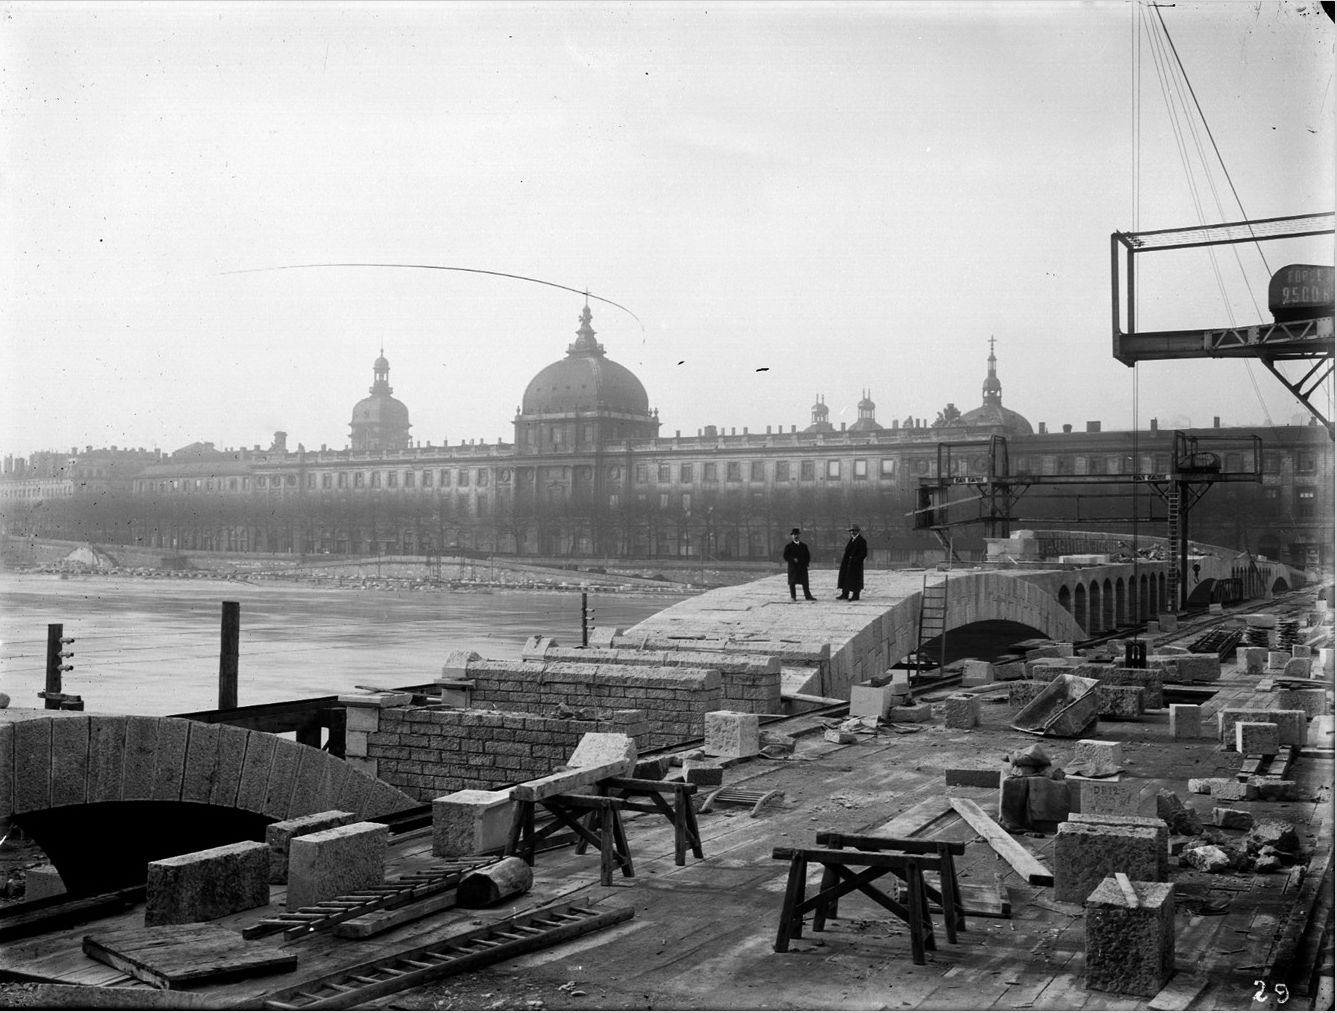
(515, 303, 659, 453)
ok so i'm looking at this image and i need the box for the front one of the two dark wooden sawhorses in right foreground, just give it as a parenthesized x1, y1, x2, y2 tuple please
(771, 847, 955, 964)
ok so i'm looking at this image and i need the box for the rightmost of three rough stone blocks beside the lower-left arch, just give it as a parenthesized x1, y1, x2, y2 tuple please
(284, 823, 390, 911)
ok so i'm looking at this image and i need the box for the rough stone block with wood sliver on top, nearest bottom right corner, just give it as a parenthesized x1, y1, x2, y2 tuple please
(1084, 875, 1175, 997)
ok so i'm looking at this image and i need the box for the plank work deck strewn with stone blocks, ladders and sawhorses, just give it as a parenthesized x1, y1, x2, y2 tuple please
(0, 646, 1333, 1009)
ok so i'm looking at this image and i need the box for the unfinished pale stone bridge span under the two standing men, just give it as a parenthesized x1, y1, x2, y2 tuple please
(616, 561, 1170, 698)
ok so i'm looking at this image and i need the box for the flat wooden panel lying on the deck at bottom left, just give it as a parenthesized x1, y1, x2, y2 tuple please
(83, 923, 297, 989)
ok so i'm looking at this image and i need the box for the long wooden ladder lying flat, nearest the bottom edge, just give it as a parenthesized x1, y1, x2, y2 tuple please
(246, 902, 634, 1009)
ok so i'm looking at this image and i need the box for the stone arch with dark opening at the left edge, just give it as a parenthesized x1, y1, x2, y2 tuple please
(0, 708, 418, 893)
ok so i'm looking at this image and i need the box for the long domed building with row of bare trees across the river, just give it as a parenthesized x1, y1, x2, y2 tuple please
(0, 306, 1333, 569)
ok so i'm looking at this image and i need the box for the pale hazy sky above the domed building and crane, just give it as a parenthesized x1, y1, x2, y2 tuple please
(0, 0, 1337, 454)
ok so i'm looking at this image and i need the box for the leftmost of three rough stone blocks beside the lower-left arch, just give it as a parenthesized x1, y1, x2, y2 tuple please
(144, 841, 269, 925)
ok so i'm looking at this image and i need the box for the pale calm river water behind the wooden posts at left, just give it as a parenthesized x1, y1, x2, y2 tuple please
(0, 573, 683, 715)
